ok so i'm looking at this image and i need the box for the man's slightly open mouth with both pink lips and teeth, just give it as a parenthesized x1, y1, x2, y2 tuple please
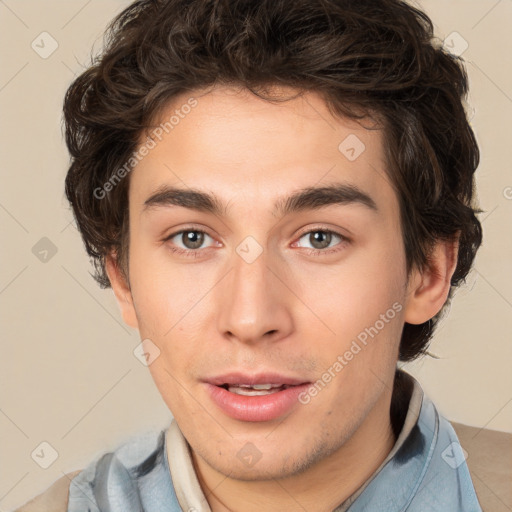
(204, 374, 311, 422)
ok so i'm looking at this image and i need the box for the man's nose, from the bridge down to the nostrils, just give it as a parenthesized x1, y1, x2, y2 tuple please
(216, 243, 294, 344)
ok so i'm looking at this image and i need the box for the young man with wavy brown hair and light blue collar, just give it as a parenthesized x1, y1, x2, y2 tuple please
(16, 0, 481, 512)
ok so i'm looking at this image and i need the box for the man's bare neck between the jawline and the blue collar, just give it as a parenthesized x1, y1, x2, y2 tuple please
(192, 386, 396, 512)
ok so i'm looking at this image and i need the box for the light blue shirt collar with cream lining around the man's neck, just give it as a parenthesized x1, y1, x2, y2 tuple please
(67, 370, 482, 512)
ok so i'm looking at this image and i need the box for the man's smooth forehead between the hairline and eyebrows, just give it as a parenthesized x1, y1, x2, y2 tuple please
(130, 87, 395, 216)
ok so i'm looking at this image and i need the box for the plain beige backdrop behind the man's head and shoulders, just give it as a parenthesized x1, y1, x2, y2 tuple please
(0, 0, 512, 511)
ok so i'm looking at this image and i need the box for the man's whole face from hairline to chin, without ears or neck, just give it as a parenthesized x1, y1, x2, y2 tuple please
(111, 87, 420, 480)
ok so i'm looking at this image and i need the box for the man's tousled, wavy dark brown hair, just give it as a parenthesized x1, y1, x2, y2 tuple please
(64, 0, 482, 361)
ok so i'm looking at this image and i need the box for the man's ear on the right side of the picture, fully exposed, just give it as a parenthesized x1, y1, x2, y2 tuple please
(404, 236, 459, 324)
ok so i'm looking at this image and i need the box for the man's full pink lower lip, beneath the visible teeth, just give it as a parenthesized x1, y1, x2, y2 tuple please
(206, 383, 311, 421)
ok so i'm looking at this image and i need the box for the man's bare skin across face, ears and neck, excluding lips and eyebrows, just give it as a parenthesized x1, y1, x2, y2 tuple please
(107, 86, 456, 512)
